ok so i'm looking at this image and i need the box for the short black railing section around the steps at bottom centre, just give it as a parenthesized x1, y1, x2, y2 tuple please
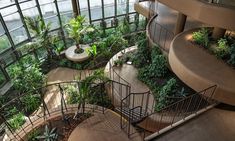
(118, 91, 155, 137)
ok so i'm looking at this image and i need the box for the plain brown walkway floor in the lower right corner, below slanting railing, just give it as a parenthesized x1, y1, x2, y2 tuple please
(154, 104, 235, 141)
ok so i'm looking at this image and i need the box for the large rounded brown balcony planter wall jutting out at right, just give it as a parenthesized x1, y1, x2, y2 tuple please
(169, 29, 235, 105)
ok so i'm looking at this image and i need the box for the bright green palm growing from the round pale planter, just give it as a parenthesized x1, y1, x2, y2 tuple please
(67, 16, 94, 54)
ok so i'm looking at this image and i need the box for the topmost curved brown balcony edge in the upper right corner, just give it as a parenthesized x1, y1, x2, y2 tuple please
(159, 0, 235, 31)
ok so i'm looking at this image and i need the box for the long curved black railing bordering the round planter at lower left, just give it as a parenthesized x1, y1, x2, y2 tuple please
(0, 79, 109, 141)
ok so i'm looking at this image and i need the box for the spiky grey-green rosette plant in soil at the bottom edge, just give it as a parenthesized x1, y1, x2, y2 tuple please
(36, 125, 58, 141)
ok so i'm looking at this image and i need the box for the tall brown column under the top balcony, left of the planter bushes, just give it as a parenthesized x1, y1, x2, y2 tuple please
(174, 12, 187, 35)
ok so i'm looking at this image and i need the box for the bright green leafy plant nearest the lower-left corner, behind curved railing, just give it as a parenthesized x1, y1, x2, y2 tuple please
(8, 108, 25, 130)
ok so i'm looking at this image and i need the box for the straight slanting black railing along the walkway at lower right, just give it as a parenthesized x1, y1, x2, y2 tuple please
(140, 85, 218, 140)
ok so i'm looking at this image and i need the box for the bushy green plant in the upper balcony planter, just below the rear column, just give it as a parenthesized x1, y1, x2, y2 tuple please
(213, 38, 229, 58)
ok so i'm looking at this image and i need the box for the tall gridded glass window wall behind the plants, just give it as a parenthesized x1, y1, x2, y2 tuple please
(0, 0, 144, 86)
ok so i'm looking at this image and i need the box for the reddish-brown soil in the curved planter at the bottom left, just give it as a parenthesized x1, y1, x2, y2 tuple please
(25, 113, 92, 141)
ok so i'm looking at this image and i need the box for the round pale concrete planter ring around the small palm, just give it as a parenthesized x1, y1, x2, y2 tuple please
(65, 45, 90, 62)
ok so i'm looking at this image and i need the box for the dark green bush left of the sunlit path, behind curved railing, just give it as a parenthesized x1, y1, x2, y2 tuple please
(21, 94, 41, 116)
